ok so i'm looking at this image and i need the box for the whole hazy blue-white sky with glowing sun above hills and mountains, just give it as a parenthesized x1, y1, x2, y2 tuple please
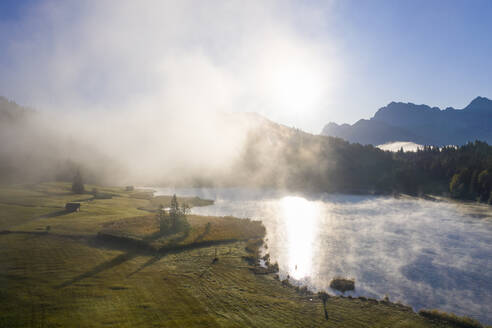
(0, 0, 492, 133)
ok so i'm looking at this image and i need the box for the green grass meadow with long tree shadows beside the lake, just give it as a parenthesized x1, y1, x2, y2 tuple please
(0, 183, 476, 327)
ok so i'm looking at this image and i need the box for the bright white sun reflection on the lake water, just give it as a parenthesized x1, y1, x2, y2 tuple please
(280, 196, 319, 279)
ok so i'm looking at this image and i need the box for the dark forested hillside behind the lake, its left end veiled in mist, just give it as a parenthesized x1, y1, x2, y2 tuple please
(235, 115, 492, 202)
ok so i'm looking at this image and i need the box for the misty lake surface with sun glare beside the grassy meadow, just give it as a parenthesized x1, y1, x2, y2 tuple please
(152, 188, 492, 324)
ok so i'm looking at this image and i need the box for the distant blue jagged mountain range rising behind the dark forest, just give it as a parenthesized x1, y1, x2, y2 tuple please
(321, 97, 492, 146)
